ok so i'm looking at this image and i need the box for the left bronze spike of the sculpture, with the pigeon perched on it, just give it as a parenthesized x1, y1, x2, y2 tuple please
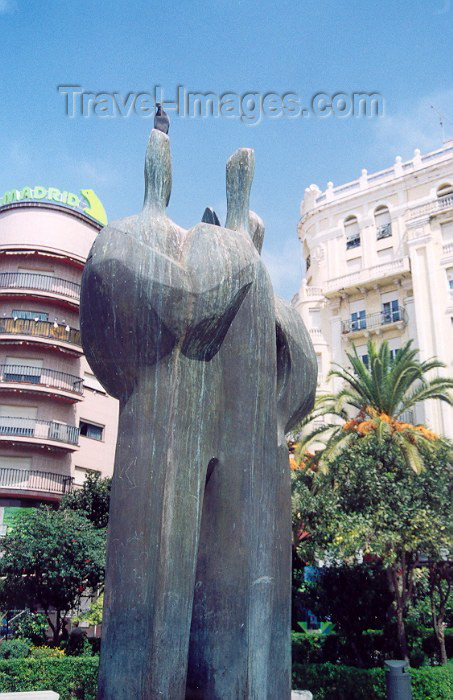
(143, 129, 171, 211)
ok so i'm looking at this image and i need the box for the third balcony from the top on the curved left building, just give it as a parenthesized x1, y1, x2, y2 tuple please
(0, 364, 83, 401)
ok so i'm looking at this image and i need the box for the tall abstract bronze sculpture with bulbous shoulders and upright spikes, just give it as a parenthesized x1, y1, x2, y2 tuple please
(81, 123, 316, 700)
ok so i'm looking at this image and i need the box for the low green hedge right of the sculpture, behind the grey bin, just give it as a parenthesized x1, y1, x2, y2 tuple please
(293, 663, 453, 700)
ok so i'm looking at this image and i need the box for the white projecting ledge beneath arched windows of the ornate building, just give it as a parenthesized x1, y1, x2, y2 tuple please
(324, 256, 410, 296)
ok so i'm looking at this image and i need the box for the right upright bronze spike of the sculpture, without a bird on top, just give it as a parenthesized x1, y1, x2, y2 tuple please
(225, 148, 255, 234)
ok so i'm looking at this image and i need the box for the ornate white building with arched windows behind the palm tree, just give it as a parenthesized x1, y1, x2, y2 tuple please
(293, 141, 453, 438)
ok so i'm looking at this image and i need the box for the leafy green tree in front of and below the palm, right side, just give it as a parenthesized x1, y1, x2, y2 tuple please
(293, 432, 453, 658)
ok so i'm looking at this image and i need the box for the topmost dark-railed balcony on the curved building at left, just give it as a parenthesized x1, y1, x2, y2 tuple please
(0, 272, 80, 305)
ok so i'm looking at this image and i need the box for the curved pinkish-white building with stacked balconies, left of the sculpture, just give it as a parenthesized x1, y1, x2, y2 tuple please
(0, 187, 118, 534)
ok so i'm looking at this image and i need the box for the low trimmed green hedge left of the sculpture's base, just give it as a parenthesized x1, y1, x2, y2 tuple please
(0, 656, 99, 700)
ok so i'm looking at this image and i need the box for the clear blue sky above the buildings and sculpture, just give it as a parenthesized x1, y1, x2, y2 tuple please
(0, 0, 453, 298)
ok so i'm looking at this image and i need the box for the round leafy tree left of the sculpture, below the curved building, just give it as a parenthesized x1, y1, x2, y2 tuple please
(0, 509, 105, 643)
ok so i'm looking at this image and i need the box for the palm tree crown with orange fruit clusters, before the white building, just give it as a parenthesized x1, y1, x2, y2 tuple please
(295, 340, 453, 473)
